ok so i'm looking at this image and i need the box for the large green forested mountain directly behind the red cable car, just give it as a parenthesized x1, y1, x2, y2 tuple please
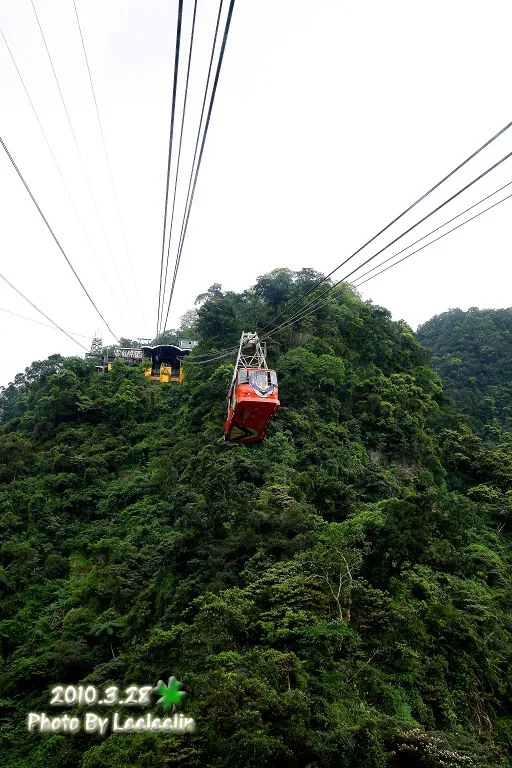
(0, 270, 512, 768)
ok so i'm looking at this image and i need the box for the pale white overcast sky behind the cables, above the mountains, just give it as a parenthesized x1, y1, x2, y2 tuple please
(0, 0, 512, 384)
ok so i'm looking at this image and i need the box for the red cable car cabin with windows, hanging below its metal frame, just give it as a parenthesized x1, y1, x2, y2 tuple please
(225, 368, 279, 444)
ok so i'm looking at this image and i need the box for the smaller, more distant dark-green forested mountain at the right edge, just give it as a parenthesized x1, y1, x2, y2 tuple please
(416, 307, 512, 446)
